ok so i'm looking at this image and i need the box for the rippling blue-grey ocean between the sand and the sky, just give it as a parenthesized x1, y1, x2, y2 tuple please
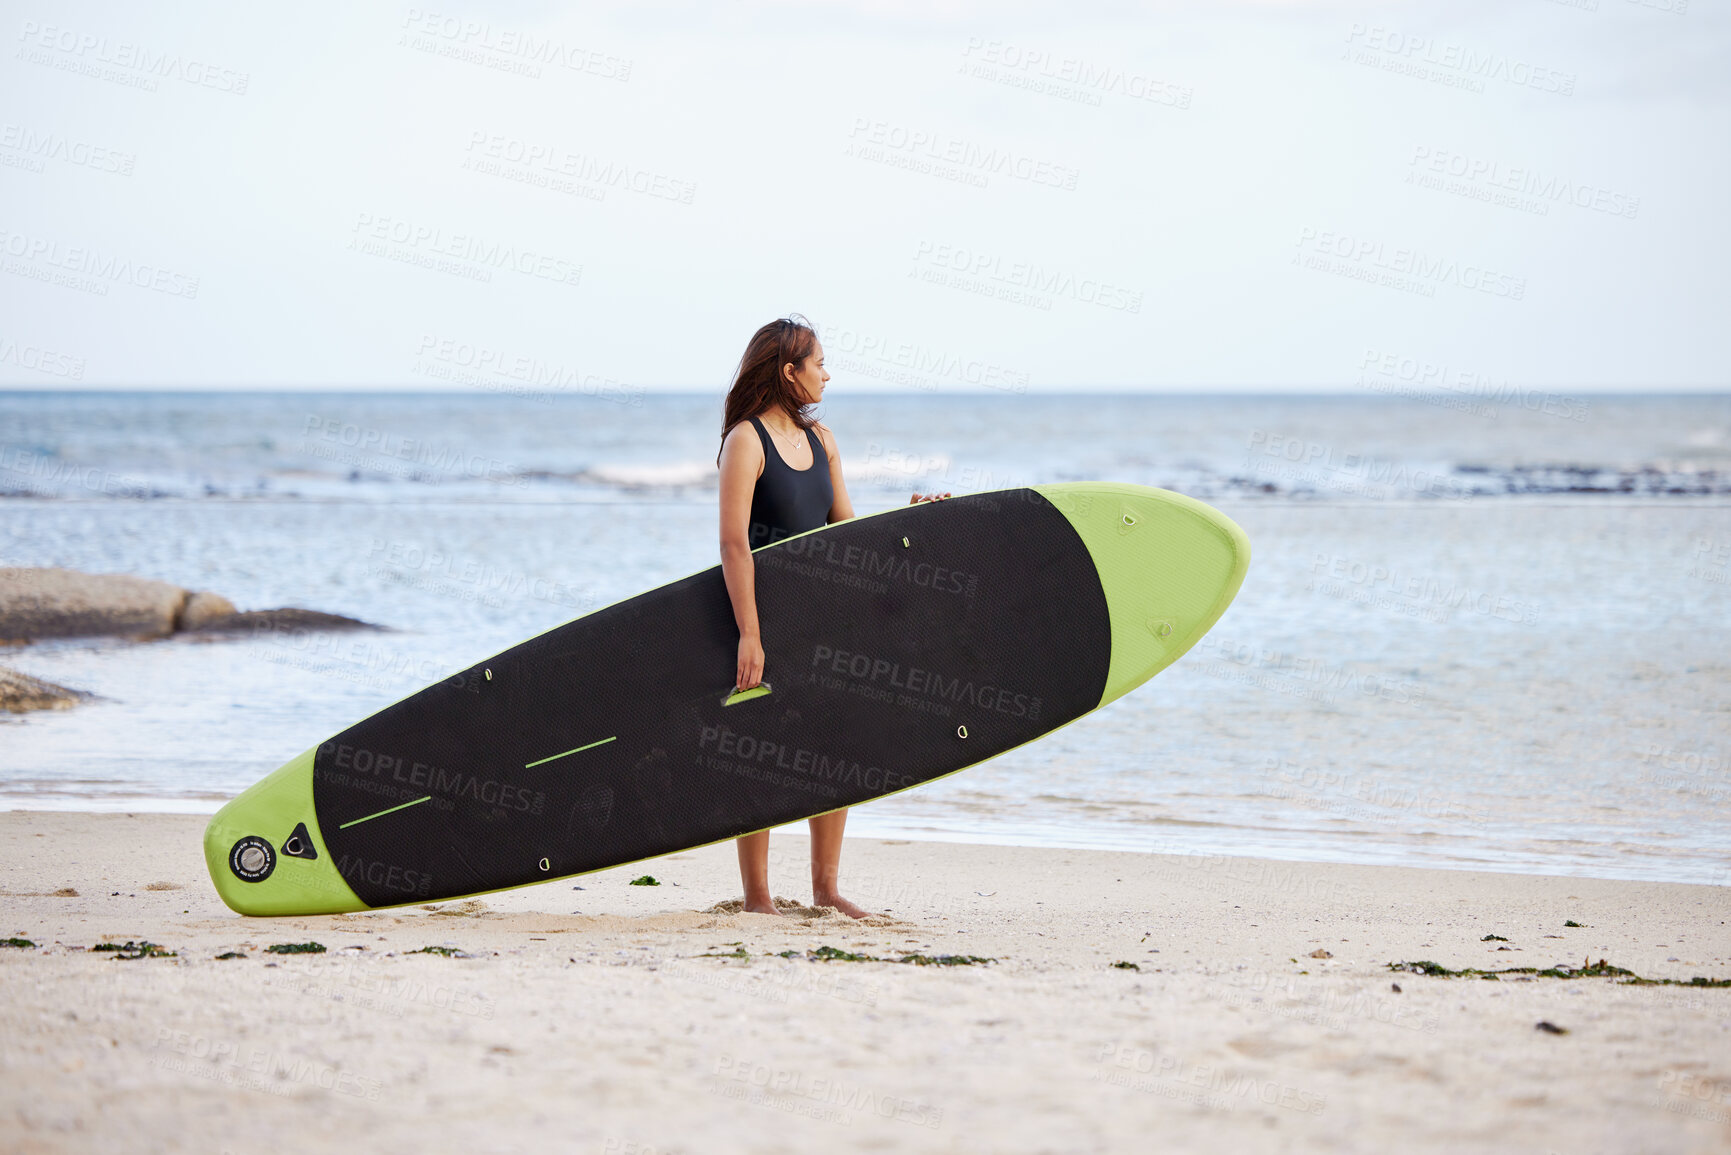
(0, 387, 1731, 885)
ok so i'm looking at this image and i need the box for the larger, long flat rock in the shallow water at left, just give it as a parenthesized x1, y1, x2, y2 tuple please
(0, 566, 379, 642)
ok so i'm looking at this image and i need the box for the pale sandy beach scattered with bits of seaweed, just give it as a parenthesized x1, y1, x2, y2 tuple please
(0, 812, 1731, 1155)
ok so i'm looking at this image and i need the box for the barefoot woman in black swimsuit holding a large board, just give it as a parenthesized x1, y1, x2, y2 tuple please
(717, 313, 949, 918)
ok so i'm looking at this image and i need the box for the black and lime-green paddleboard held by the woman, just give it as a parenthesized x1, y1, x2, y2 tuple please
(204, 483, 1250, 914)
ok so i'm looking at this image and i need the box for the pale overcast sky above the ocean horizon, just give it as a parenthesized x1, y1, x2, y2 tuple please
(0, 0, 1731, 390)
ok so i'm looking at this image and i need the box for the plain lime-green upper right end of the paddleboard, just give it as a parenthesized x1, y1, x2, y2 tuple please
(1033, 481, 1250, 705)
